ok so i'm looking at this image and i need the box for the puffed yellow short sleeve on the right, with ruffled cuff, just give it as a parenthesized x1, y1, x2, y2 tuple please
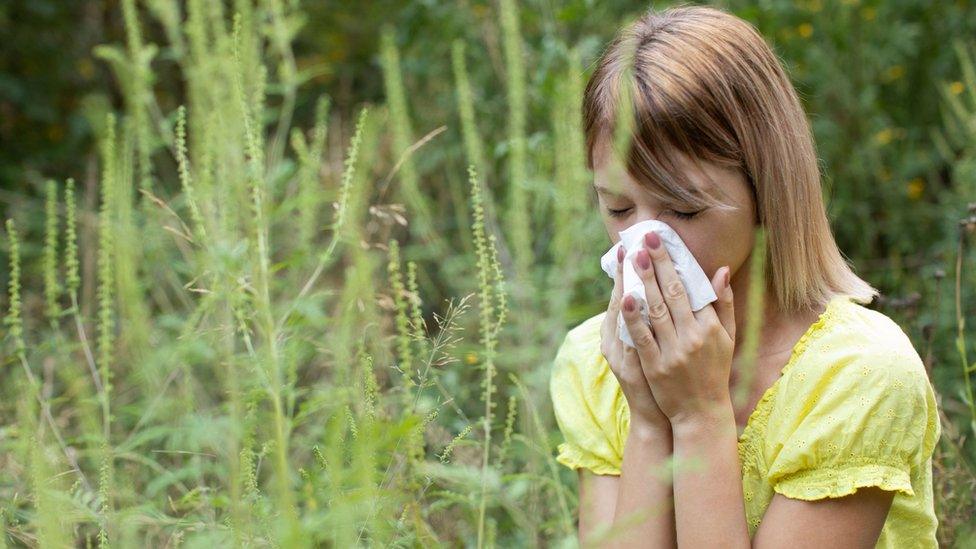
(767, 345, 940, 500)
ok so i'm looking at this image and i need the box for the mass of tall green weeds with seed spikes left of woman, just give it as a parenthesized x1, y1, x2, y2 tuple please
(0, 0, 556, 547)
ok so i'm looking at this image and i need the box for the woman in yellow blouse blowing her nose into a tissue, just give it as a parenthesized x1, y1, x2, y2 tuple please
(550, 6, 941, 548)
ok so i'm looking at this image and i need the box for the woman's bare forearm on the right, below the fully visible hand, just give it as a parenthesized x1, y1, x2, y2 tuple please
(672, 402, 751, 548)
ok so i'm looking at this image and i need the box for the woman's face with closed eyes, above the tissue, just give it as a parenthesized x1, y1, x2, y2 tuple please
(593, 146, 756, 280)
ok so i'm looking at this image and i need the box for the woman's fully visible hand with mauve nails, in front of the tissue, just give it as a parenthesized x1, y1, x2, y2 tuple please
(623, 232, 735, 428)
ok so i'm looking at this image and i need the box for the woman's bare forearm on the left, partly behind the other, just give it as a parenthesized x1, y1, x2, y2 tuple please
(608, 424, 676, 549)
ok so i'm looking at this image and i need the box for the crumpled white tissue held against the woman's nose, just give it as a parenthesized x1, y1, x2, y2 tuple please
(600, 219, 718, 347)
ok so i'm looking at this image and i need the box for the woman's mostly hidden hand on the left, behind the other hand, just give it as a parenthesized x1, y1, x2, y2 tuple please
(600, 246, 671, 430)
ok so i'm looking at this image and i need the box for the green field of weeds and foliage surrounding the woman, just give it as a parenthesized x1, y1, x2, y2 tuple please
(0, 0, 976, 548)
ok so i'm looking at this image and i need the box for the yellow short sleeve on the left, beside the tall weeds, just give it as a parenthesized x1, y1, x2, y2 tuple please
(549, 318, 629, 475)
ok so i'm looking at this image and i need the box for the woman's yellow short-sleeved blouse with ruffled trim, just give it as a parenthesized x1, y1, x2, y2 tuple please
(549, 296, 942, 548)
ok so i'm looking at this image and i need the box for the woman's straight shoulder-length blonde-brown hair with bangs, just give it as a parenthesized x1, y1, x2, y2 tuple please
(582, 5, 879, 312)
